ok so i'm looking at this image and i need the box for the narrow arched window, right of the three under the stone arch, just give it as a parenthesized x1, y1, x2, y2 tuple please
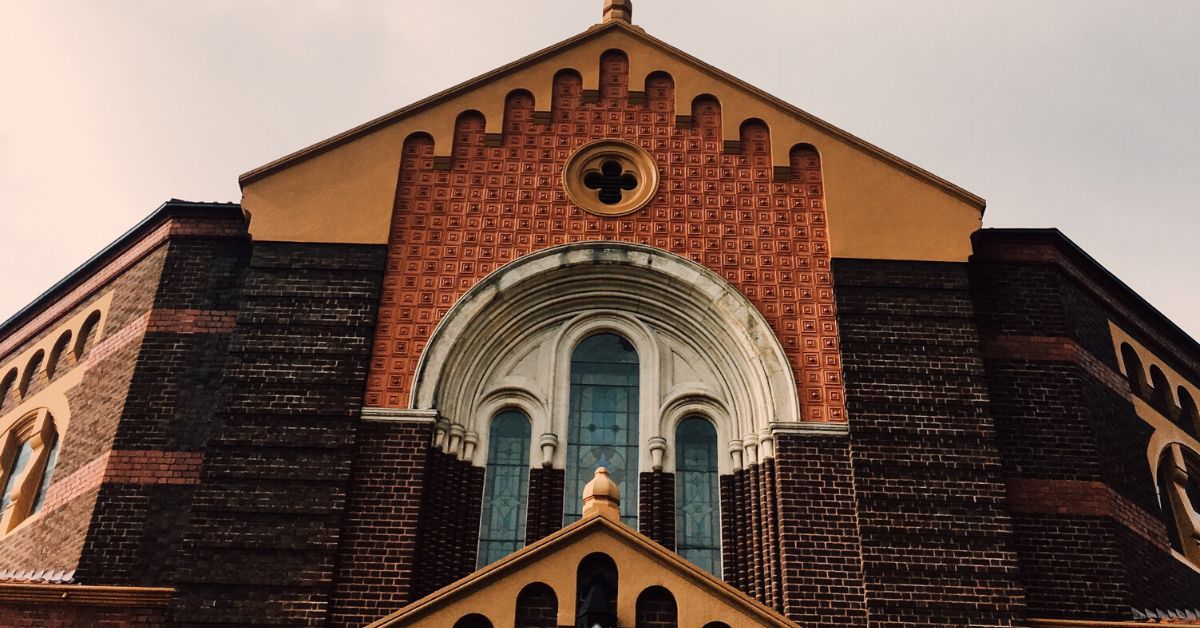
(676, 417, 721, 578)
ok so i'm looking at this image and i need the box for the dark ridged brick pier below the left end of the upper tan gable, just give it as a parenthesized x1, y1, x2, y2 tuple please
(170, 243, 384, 626)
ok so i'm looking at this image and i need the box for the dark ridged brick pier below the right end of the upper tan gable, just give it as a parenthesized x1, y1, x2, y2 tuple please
(834, 259, 1024, 626)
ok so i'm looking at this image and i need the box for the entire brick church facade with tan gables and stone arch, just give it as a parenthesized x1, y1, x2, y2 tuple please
(0, 0, 1200, 627)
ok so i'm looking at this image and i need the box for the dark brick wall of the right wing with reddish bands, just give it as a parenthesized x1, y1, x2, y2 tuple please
(970, 232, 1200, 620)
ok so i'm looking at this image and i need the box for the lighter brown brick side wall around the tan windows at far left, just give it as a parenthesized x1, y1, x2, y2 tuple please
(0, 210, 191, 579)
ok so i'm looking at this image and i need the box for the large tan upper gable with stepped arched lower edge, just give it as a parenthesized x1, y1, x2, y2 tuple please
(241, 22, 984, 261)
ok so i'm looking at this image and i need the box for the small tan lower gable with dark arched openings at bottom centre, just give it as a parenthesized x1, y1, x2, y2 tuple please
(371, 515, 796, 628)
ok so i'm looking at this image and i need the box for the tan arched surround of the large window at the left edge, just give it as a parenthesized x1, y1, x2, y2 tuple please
(0, 408, 58, 534)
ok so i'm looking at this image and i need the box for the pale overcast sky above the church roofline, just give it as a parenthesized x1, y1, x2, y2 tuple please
(0, 0, 1200, 337)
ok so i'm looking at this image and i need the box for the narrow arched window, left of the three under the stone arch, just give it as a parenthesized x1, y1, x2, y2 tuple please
(478, 409, 529, 567)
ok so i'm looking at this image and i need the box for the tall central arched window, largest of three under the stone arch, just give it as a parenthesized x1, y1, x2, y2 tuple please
(563, 333, 638, 530)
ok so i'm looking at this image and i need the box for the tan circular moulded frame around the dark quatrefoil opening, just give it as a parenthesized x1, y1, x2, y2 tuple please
(563, 138, 659, 217)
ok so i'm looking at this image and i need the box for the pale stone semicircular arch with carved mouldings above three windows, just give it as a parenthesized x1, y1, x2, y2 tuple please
(410, 243, 800, 473)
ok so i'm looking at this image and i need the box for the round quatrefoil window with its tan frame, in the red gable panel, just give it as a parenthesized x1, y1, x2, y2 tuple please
(563, 139, 659, 216)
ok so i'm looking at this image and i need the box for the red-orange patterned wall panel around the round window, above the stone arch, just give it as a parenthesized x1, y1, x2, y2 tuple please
(366, 48, 845, 420)
